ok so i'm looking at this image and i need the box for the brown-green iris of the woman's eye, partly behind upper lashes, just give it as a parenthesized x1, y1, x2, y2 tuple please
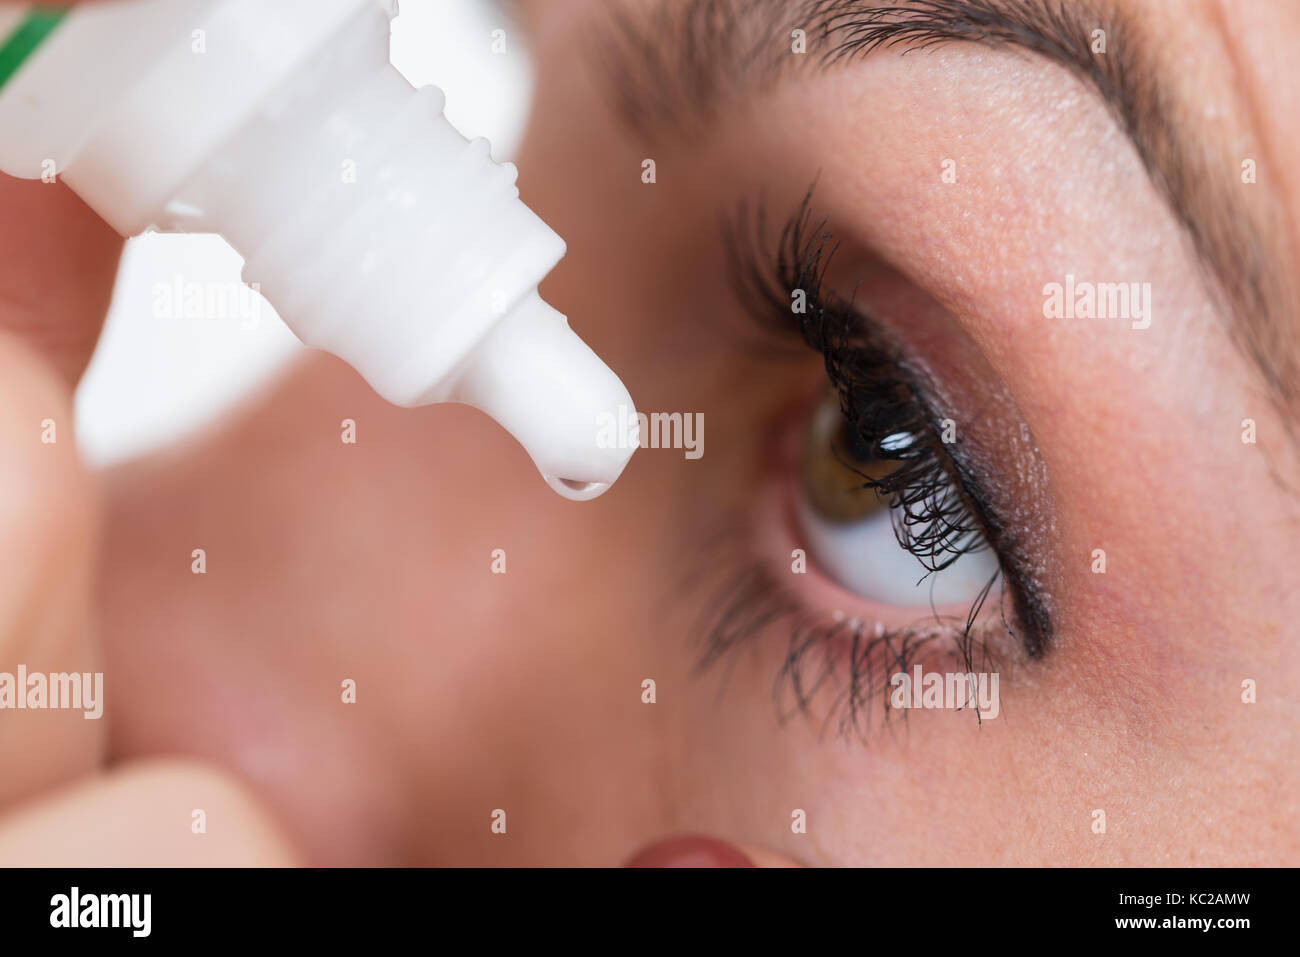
(800, 393, 901, 525)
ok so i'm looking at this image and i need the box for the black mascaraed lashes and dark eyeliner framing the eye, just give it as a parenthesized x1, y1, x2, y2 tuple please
(701, 183, 1052, 732)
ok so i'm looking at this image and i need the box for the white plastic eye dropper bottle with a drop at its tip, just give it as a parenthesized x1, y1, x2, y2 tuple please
(0, 0, 636, 501)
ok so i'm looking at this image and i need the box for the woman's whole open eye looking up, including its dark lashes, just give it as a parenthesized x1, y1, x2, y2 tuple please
(705, 180, 1050, 731)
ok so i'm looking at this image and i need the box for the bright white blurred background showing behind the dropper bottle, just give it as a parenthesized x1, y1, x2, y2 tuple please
(77, 0, 532, 465)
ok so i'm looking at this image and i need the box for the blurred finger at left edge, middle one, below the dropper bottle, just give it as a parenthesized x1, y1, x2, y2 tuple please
(0, 330, 102, 809)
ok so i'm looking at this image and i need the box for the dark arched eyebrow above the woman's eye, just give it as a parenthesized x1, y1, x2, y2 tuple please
(594, 0, 1300, 434)
